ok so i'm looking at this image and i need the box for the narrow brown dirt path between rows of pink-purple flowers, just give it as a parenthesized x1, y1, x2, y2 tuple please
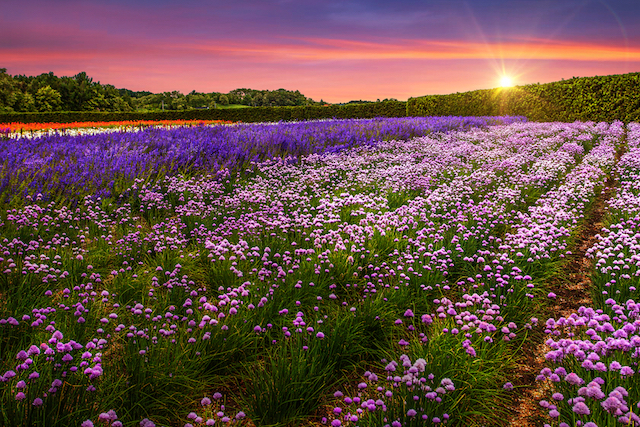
(507, 145, 624, 427)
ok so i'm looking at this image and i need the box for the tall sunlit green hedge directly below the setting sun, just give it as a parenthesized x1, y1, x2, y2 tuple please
(407, 73, 640, 122)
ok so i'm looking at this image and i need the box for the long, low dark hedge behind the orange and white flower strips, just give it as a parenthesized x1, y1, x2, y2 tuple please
(0, 101, 407, 123)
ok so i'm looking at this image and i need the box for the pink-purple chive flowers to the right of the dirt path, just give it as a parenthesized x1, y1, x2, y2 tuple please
(538, 123, 640, 427)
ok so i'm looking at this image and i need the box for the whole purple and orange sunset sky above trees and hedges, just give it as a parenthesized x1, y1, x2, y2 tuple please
(0, 0, 640, 103)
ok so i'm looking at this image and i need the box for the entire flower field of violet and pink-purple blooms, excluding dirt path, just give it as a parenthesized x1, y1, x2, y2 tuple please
(0, 117, 640, 427)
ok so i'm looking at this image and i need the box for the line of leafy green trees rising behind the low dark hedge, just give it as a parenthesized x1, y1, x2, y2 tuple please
(0, 68, 325, 113)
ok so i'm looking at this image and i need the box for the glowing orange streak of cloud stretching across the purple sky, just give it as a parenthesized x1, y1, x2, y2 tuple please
(6, 34, 640, 63)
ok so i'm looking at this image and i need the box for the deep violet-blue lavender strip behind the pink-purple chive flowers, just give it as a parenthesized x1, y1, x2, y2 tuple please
(0, 117, 525, 204)
